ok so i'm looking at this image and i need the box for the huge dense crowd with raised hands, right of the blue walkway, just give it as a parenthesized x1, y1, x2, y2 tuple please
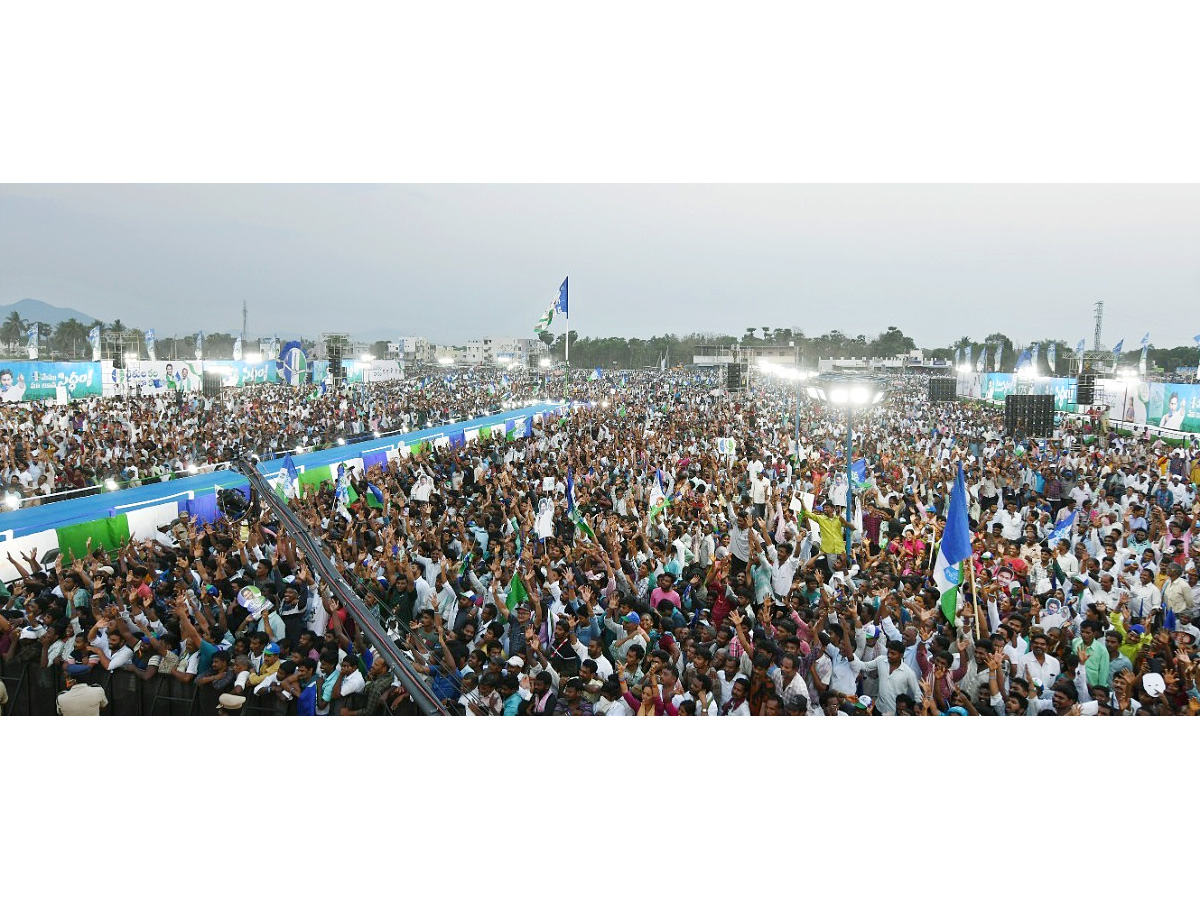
(0, 372, 1200, 716)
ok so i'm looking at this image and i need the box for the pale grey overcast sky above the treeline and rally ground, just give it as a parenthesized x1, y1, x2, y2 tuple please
(0, 185, 1200, 347)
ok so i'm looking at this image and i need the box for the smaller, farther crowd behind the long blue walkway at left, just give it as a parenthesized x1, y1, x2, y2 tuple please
(0, 370, 552, 506)
